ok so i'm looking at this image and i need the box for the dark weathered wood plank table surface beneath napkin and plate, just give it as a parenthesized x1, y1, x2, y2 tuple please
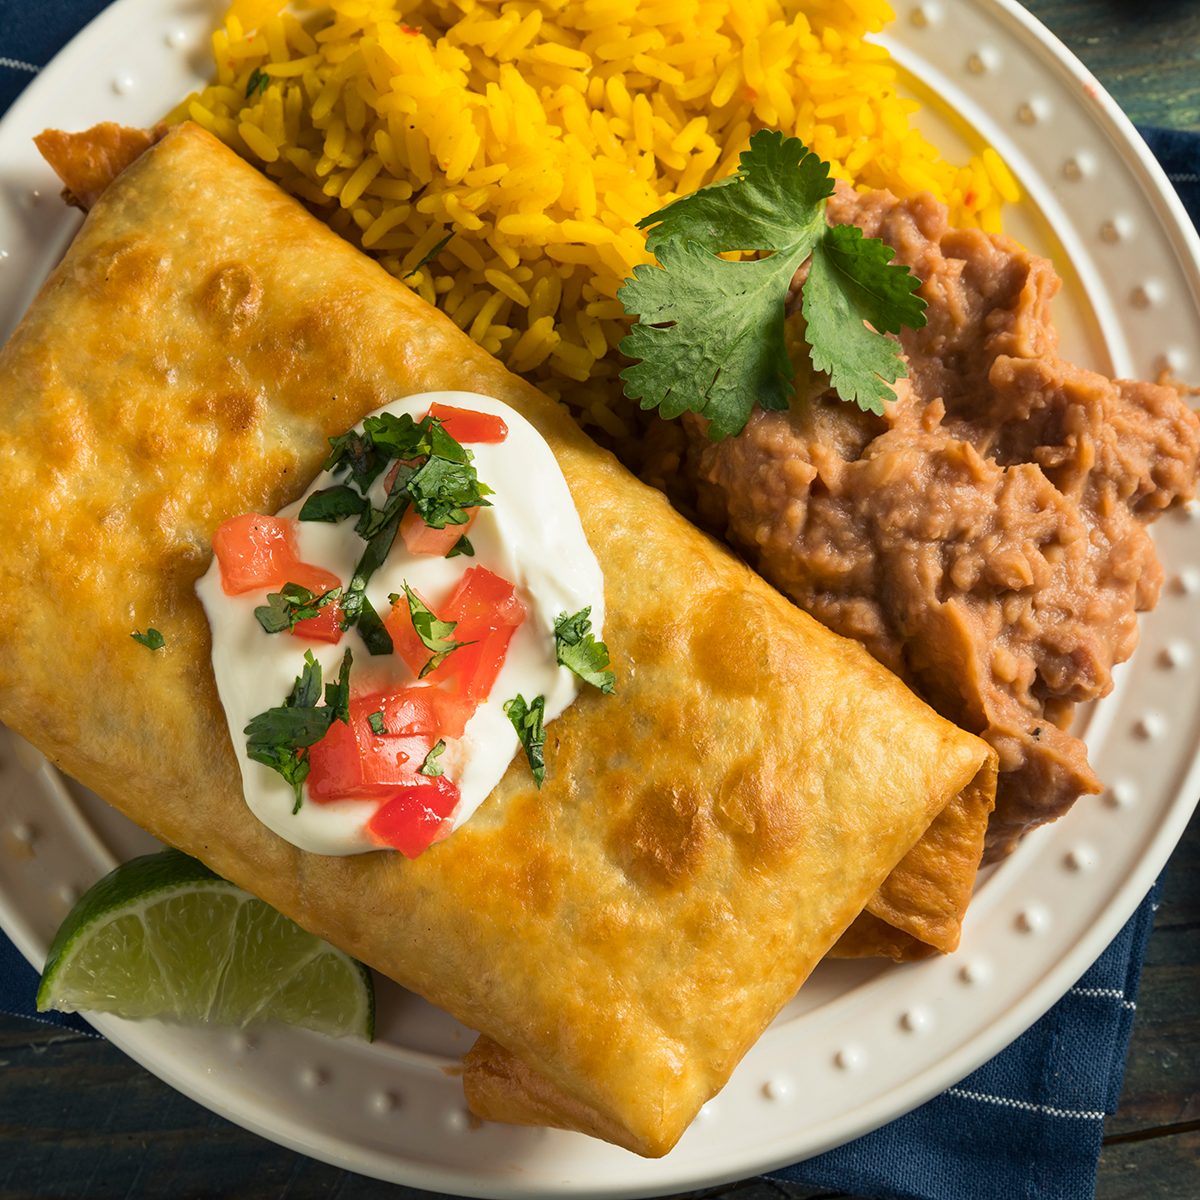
(0, 0, 1200, 1200)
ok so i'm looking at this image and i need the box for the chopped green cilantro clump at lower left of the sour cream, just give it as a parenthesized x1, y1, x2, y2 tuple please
(242, 650, 353, 812)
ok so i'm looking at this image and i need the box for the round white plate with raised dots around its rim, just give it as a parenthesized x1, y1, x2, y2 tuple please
(0, 0, 1200, 1196)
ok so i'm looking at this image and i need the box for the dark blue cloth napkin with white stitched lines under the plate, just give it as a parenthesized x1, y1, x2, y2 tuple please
(0, 9, 1200, 1200)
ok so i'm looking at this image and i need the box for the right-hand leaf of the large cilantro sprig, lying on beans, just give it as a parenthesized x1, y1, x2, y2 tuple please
(802, 226, 925, 415)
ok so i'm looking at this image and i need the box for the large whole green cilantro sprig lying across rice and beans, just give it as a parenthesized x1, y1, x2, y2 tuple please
(618, 130, 925, 440)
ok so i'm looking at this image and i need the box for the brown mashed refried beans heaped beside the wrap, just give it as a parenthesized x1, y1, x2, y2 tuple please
(643, 187, 1200, 858)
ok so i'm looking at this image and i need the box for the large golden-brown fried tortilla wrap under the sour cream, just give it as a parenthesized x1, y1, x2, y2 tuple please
(0, 125, 994, 1156)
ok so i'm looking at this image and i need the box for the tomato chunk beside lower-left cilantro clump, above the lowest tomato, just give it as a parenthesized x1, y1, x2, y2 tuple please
(307, 692, 437, 803)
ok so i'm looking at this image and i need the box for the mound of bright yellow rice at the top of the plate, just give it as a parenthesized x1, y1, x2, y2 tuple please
(170, 0, 1016, 436)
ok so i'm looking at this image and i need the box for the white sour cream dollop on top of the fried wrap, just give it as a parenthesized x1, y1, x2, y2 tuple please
(196, 391, 604, 854)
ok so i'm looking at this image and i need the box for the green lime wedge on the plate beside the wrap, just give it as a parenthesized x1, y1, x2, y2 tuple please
(37, 850, 374, 1040)
